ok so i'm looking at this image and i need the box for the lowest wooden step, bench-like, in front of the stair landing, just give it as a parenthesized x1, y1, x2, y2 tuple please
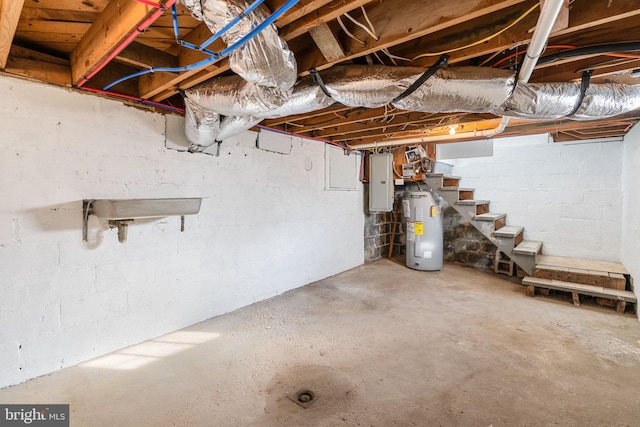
(522, 277, 638, 313)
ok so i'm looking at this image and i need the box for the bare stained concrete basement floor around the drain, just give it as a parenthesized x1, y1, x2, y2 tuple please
(0, 260, 640, 427)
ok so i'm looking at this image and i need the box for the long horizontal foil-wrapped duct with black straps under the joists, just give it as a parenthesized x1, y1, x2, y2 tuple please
(180, 65, 640, 149)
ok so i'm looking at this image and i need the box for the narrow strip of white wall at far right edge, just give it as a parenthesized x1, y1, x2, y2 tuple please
(622, 124, 640, 310)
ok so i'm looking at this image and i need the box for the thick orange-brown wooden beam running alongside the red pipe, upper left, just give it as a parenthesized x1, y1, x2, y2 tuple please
(71, 0, 168, 84)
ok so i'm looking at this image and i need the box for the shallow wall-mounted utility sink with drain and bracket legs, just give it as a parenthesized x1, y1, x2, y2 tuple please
(82, 198, 202, 243)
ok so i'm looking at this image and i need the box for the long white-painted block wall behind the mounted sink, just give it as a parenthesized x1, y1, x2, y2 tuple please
(0, 77, 364, 387)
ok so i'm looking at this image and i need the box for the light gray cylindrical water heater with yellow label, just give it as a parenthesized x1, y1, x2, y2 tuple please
(402, 191, 444, 271)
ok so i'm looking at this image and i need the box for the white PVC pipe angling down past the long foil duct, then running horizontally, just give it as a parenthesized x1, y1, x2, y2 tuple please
(364, 0, 565, 149)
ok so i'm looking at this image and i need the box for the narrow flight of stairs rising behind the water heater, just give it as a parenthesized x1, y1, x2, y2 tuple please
(425, 173, 542, 276)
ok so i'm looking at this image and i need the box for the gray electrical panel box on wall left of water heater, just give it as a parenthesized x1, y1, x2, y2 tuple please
(369, 153, 393, 212)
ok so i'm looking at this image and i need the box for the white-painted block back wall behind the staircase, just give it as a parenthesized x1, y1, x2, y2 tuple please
(449, 135, 623, 261)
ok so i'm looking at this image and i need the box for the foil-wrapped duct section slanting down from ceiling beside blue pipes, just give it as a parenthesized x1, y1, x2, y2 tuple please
(180, 0, 298, 90)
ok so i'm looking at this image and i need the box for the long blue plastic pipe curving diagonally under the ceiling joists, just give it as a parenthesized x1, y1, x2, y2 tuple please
(102, 0, 300, 90)
